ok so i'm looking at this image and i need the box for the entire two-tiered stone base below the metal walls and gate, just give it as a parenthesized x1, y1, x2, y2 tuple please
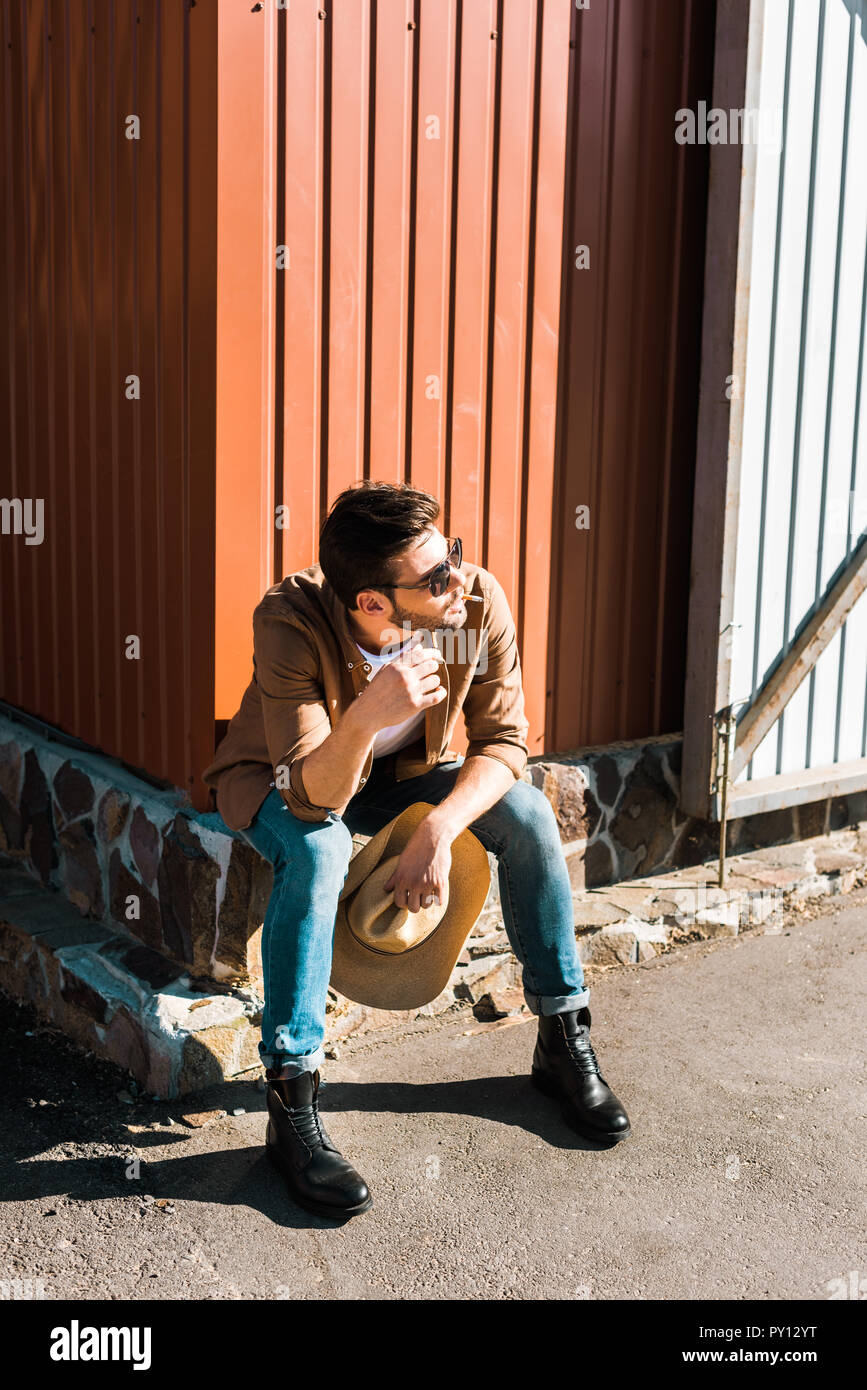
(0, 716, 867, 1095)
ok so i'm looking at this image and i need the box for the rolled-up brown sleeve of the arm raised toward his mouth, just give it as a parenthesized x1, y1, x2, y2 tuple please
(253, 605, 333, 820)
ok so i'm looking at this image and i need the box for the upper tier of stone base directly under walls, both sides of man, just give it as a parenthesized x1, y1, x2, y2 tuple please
(0, 716, 867, 997)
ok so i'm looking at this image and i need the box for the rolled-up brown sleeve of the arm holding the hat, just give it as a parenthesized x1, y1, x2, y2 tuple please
(464, 573, 529, 780)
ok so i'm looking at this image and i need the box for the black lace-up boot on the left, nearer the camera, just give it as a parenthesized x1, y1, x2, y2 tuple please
(265, 1070, 374, 1218)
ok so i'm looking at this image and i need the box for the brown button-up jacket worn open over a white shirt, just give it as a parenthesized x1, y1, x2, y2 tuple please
(201, 562, 529, 830)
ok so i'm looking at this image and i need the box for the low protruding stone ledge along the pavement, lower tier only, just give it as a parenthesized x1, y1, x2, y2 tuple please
(0, 823, 867, 1098)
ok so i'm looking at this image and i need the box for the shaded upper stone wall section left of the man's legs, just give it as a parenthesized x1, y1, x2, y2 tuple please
(0, 717, 271, 983)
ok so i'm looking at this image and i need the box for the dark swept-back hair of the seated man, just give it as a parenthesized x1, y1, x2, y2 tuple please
(320, 481, 439, 609)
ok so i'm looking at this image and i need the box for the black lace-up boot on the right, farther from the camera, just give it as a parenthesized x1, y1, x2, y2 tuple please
(531, 1008, 632, 1145)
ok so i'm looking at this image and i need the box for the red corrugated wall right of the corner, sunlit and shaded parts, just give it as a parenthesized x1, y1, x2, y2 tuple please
(217, 0, 714, 752)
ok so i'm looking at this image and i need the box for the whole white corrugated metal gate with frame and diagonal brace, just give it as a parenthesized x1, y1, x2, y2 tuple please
(681, 0, 867, 820)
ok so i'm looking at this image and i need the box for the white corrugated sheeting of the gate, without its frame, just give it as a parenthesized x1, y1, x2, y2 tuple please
(731, 0, 867, 781)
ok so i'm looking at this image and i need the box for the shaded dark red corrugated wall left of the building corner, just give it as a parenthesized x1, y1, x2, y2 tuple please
(0, 0, 217, 788)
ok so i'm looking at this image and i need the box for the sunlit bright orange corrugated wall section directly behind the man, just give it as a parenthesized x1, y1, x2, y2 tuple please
(217, 0, 574, 748)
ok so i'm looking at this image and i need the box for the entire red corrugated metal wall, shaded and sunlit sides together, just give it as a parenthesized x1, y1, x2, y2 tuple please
(0, 0, 713, 805)
